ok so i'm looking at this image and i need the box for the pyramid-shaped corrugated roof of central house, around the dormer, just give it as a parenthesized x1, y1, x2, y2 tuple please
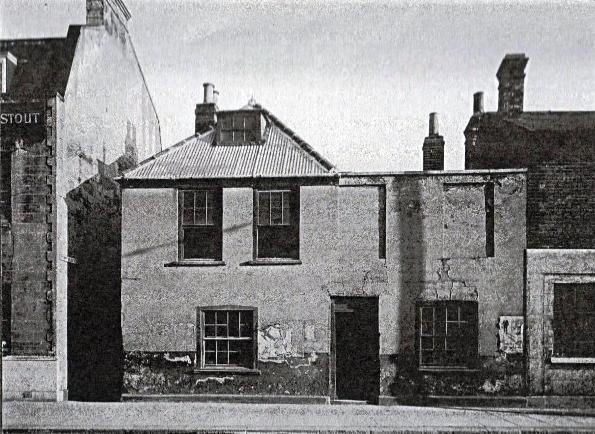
(122, 105, 336, 180)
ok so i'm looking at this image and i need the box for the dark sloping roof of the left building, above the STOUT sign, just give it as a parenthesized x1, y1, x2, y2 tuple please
(0, 26, 81, 98)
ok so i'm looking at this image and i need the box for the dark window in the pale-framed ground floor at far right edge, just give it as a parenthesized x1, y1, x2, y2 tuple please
(554, 283, 595, 357)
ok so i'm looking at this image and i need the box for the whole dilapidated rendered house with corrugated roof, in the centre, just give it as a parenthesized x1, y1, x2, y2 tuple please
(119, 83, 526, 402)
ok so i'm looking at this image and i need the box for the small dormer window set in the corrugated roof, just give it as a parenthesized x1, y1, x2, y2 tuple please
(217, 110, 261, 144)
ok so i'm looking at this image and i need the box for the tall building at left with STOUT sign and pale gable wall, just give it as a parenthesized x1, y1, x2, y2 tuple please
(0, 0, 161, 400)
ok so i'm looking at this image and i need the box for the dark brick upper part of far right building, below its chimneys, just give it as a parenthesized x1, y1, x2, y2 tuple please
(465, 118, 595, 249)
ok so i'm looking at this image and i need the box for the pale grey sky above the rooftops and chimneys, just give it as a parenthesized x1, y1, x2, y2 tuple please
(0, 0, 595, 171)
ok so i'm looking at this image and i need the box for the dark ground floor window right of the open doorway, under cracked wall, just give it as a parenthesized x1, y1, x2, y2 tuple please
(416, 300, 478, 368)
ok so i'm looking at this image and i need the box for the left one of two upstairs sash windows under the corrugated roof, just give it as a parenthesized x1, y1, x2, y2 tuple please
(178, 189, 223, 261)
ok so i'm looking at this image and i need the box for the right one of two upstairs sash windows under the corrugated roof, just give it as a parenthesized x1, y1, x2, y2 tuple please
(255, 188, 300, 259)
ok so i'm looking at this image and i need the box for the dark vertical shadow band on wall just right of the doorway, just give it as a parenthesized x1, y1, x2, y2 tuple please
(387, 177, 426, 404)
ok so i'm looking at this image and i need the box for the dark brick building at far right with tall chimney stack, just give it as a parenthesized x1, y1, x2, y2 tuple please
(465, 54, 595, 395)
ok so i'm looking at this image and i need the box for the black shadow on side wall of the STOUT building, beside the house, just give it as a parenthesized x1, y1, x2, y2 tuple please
(66, 169, 123, 401)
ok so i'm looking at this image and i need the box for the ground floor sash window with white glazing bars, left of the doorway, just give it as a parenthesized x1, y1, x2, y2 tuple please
(197, 306, 257, 370)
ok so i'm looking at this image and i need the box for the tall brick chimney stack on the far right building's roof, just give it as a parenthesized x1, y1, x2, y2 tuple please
(496, 54, 529, 114)
